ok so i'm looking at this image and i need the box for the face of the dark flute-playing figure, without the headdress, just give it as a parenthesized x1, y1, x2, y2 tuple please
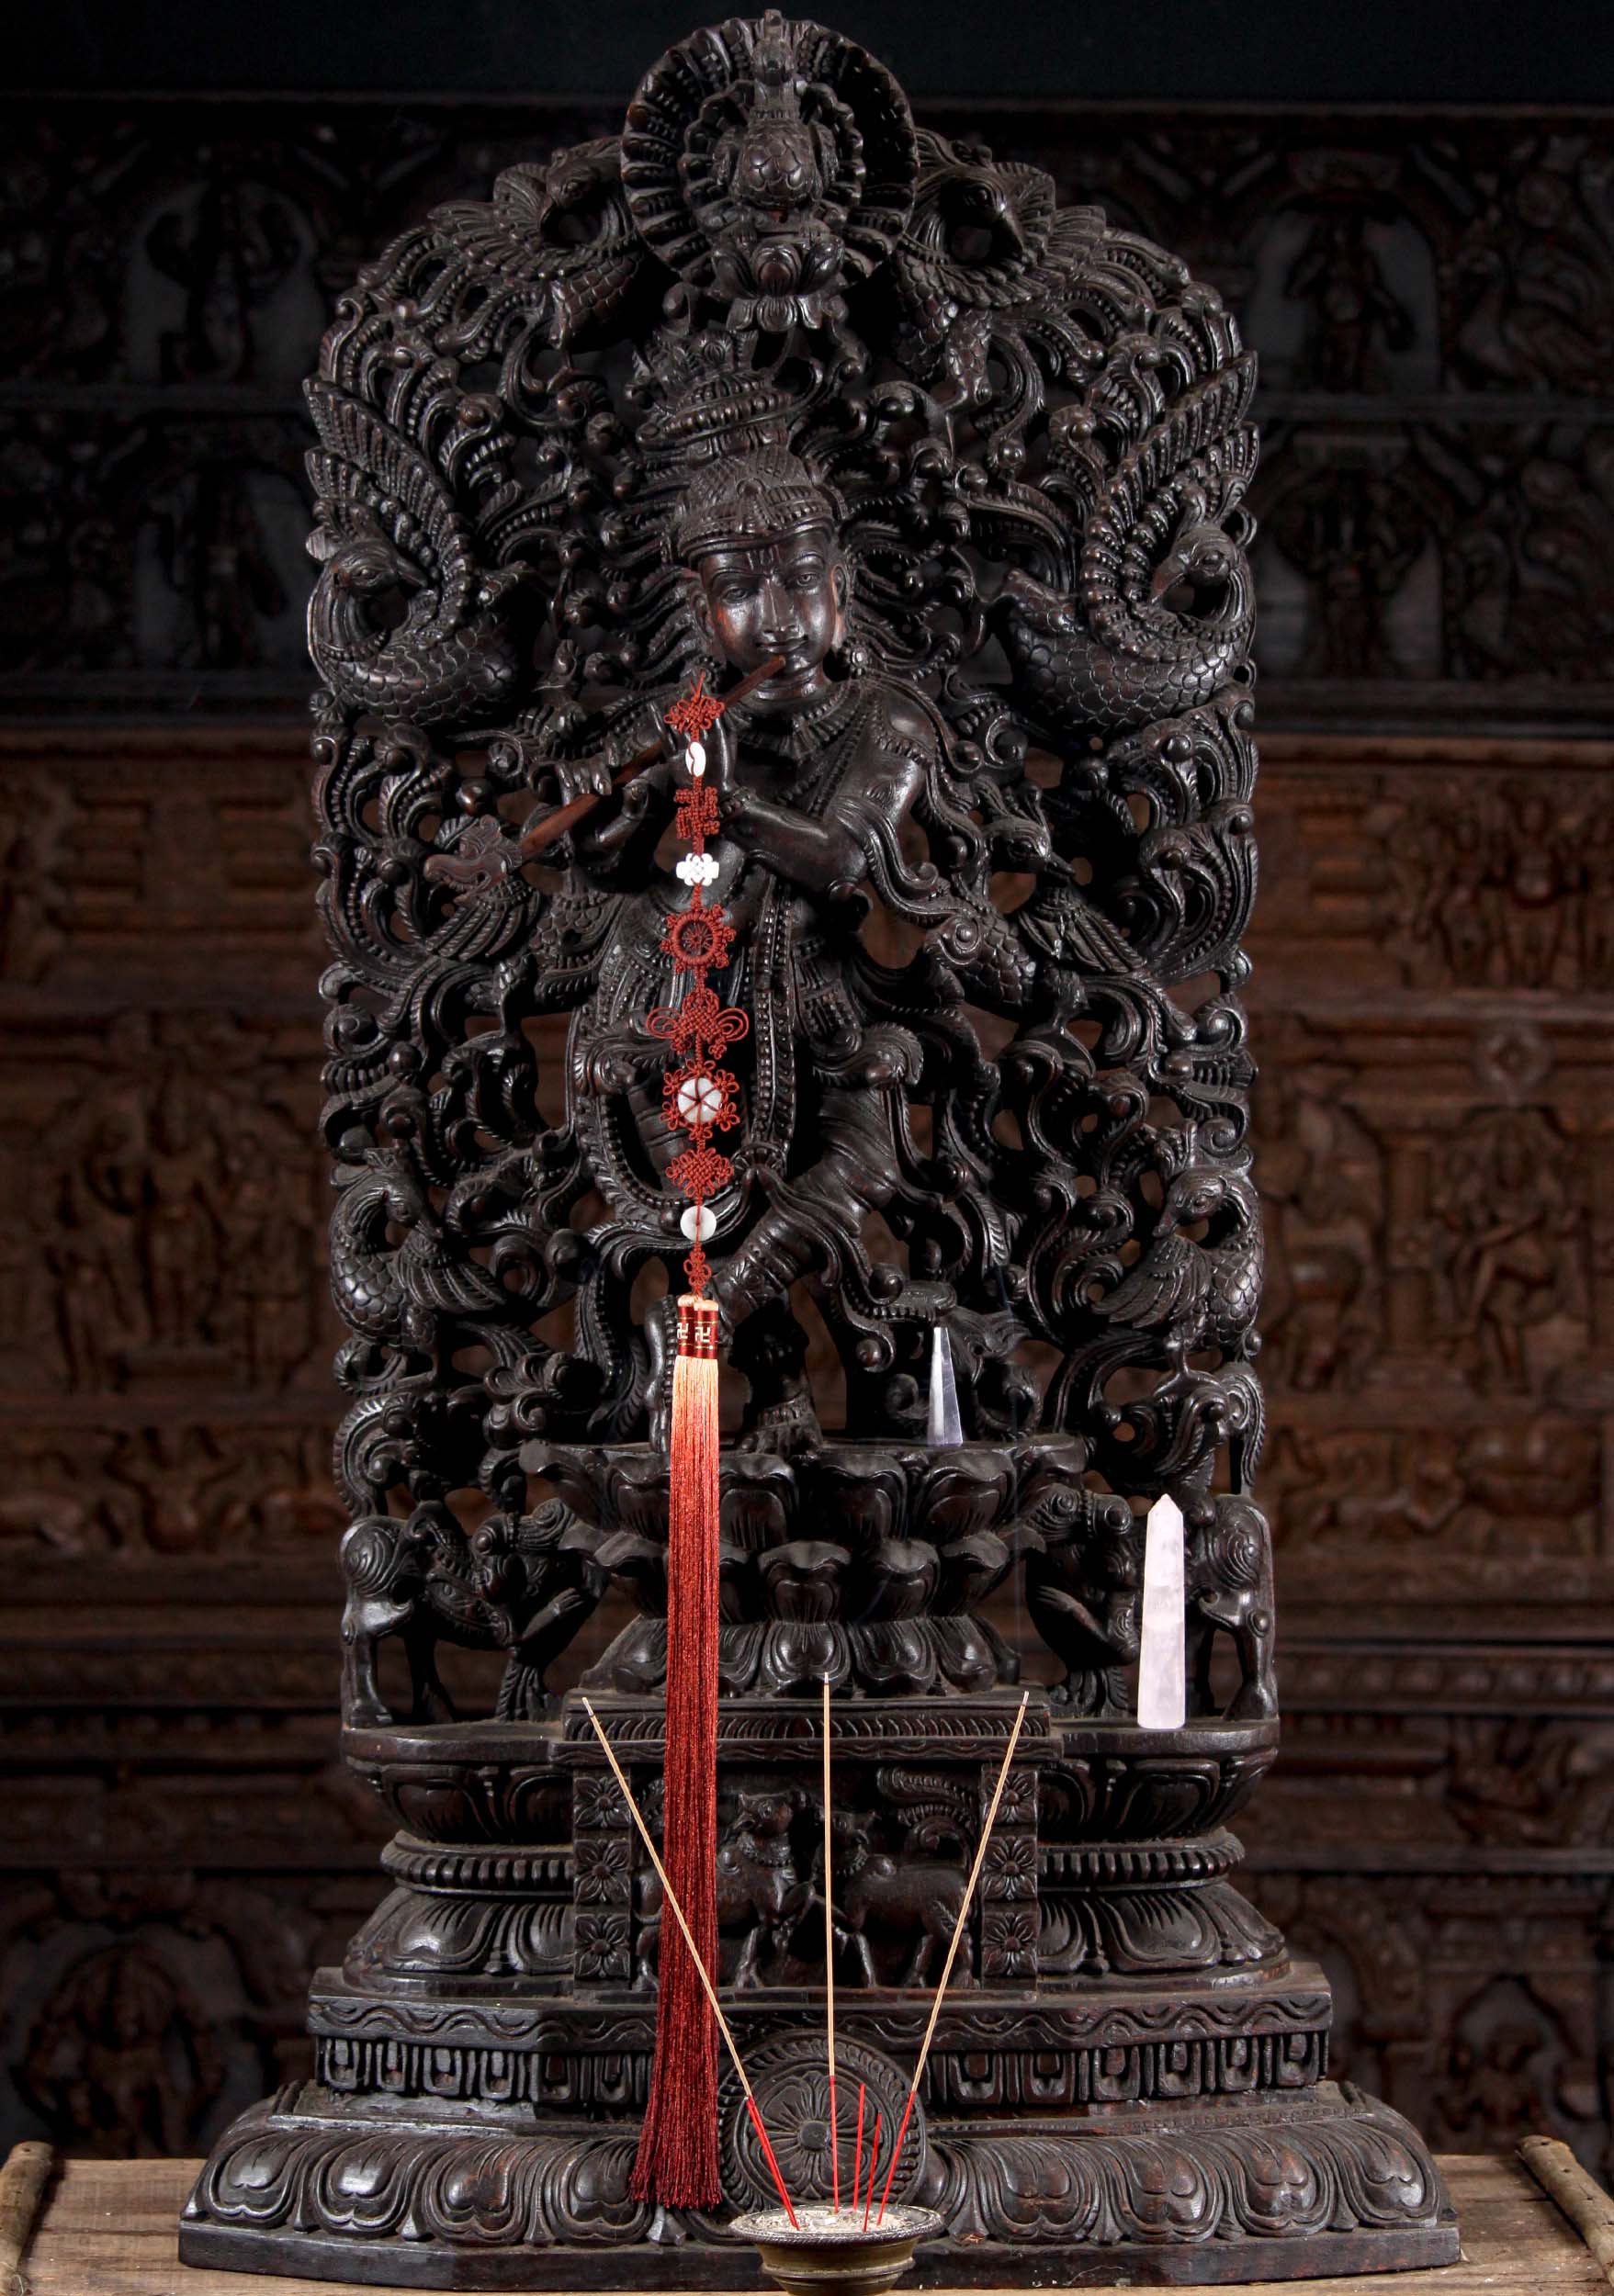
(694, 526, 847, 710)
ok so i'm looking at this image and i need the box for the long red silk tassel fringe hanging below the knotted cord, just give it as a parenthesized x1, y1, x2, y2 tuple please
(629, 1293, 723, 2209)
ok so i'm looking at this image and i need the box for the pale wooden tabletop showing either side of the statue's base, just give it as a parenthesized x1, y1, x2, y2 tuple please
(12, 2154, 1609, 2296)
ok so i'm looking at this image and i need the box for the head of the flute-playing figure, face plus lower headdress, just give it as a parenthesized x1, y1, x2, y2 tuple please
(671, 445, 852, 710)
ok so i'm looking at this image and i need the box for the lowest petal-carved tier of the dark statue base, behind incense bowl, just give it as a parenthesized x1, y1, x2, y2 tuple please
(179, 2085, 1458, 2290)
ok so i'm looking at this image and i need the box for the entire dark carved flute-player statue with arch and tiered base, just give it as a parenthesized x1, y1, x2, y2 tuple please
(181, 12, 1456, 2290)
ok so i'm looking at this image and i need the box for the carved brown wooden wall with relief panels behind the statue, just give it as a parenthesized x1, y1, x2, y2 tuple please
(0, 0, 1614, 2163)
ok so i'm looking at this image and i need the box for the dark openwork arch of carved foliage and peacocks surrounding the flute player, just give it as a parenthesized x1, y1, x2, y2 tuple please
(308, 17, 1260, 1699)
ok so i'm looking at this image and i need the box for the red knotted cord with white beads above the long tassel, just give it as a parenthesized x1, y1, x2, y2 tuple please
(648, 680, 751, 1304)
